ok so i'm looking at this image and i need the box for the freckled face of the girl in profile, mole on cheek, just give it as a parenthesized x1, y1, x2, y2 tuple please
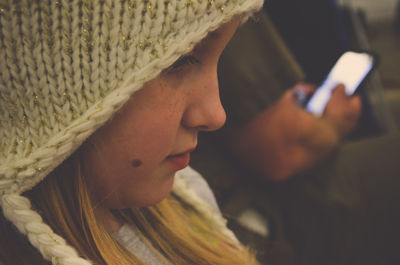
(84, 19, 239, 209)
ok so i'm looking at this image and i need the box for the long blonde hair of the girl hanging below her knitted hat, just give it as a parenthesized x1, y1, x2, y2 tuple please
(0, 152, 258, 265)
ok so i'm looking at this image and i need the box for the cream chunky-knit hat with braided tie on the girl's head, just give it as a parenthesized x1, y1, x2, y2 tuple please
(0, 0, 262, 264)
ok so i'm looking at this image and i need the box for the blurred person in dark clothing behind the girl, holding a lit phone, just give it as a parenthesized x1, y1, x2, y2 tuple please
(192, 5, 400, 264)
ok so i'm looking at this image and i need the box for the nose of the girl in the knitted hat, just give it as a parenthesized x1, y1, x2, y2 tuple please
(182, 71, 226, 131)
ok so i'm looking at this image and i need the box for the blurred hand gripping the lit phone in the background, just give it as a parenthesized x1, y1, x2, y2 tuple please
(229, 84, 361, 181)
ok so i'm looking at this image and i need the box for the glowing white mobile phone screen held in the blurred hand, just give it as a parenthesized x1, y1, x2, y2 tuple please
(305, 51, 376, 116)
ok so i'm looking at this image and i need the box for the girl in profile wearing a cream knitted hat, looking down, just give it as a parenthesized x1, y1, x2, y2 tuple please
(0, 0, 262, 265)
